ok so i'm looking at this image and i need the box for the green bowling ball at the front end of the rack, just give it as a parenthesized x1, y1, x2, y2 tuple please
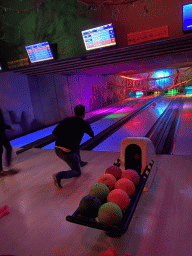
(98, 202, 123, 225)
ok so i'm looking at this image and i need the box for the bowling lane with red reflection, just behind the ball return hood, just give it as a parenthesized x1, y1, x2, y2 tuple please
(93, 98, 170, 152)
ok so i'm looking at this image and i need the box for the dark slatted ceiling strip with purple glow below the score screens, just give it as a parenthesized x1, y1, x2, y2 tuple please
(7, 35, 192, 76)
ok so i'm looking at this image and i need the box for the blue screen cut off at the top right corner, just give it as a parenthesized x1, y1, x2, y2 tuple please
(183, 3, 192, 33)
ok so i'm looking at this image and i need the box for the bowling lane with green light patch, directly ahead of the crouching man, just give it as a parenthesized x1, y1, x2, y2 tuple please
(43, 96, 158, 149)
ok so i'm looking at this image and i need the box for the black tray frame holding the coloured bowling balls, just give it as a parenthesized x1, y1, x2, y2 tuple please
(66, 160, 154, 237)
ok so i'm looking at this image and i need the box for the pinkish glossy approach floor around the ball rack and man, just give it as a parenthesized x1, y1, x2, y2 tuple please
(0, 116, 192, 256)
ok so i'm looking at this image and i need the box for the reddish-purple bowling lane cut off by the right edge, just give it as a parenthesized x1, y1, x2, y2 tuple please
(172, 95, 192, 155)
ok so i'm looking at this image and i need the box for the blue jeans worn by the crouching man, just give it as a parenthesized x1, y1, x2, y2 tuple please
(55, 148, 81, 179)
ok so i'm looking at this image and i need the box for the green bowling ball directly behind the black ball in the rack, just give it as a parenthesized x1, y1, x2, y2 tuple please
(89, 183, 110, 203)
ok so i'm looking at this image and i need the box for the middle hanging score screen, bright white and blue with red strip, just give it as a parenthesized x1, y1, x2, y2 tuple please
(81, 24, 116, 51)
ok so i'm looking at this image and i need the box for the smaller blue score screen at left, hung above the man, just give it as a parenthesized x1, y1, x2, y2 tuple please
(25, 42, 54, 63)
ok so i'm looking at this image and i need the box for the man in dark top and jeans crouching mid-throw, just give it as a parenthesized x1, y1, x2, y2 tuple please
(52, 105, 94, 188)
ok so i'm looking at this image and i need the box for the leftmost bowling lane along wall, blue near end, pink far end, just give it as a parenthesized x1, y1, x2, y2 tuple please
(11, 98, 136, 148)
